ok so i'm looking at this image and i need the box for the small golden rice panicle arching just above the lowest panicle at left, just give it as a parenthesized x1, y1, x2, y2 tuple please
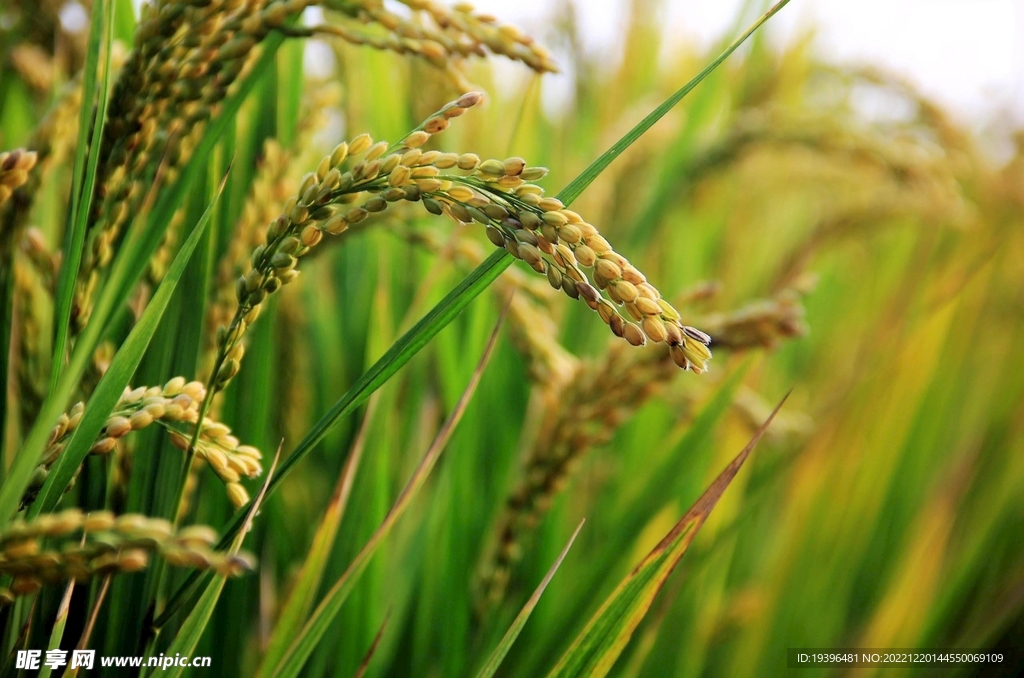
(32, 377, 263, 506)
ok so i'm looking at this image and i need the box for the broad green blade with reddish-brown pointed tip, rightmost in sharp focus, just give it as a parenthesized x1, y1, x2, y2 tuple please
(549, 397, 785, 678)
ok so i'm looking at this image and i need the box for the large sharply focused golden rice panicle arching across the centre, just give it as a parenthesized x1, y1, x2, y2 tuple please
(210, 92, 711, 399)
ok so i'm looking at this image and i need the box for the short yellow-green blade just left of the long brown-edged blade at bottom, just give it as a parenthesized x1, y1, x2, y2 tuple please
(263, 398, 377, 666)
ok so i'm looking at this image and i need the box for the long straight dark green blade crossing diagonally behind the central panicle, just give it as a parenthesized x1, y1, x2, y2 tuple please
(154, 0, 788, 628)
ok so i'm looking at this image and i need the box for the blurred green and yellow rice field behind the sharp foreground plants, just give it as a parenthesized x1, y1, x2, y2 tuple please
(0, 0, 1024, 678)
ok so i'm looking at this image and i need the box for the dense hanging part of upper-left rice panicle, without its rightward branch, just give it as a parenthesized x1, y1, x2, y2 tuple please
(73, 0, 315, 329)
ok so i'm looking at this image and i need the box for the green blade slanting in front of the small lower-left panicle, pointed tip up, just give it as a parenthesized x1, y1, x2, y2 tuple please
(30, 174, 227, 515)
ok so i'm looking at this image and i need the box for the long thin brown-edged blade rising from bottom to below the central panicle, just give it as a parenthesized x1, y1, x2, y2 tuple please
(257, 313, 505, 678)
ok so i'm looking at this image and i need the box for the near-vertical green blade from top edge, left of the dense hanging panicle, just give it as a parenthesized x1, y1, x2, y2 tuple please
(50, 0, 117, 389)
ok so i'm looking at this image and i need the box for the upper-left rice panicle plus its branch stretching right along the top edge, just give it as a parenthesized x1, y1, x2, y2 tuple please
(73, 0, 554, 330)
